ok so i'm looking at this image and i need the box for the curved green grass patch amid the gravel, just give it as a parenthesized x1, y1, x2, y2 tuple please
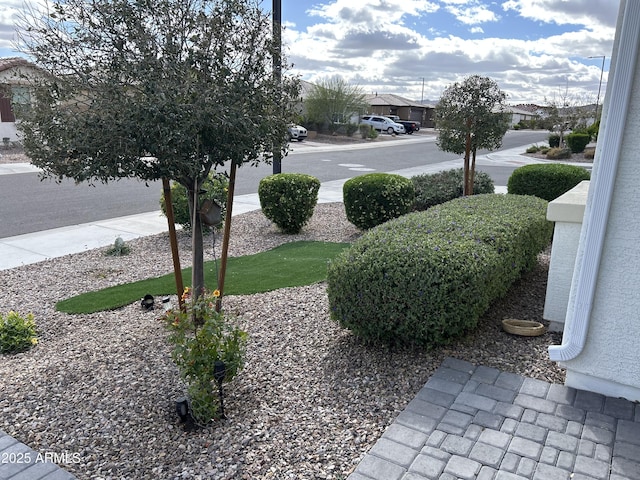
(56, 241, 350, 314)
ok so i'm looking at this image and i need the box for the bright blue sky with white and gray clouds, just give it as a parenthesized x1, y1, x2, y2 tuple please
(0, 0, 619, 105)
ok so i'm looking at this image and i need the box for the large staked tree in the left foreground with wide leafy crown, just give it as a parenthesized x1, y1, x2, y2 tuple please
(19, 0, 298, 295)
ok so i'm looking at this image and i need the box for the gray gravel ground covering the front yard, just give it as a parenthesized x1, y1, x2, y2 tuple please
(0, 204, 563, 479)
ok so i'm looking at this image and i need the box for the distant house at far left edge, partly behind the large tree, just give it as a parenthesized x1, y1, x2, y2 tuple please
(0, 57, 37, 141)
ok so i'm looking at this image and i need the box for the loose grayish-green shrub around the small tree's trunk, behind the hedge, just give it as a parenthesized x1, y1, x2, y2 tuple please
(411, 168, 494, 210)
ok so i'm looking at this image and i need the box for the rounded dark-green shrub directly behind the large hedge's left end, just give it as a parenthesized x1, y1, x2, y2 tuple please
(342, 173, 415, 230)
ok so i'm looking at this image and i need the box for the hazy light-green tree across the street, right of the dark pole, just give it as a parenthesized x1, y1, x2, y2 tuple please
(304, 76, 367, 130)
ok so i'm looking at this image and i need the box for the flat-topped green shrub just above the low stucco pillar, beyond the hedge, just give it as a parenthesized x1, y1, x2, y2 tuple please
(507, 163, 591, 201)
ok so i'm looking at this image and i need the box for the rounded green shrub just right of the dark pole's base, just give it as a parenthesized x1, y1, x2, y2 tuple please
(258, 173, 320, 233)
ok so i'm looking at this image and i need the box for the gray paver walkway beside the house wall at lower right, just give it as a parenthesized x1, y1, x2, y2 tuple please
(348, 358, 640, 480)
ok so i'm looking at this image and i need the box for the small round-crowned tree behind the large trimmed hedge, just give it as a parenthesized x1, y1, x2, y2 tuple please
(435, 75, 509, 195)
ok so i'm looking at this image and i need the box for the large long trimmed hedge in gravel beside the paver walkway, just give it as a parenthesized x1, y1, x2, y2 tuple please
(327, 195, 553, 346)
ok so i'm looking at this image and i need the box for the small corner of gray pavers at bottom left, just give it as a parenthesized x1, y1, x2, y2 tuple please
(0, 430, 76, 480)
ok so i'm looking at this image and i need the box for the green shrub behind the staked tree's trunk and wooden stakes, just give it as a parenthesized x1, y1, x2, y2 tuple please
(160, 173, 229, 231)
